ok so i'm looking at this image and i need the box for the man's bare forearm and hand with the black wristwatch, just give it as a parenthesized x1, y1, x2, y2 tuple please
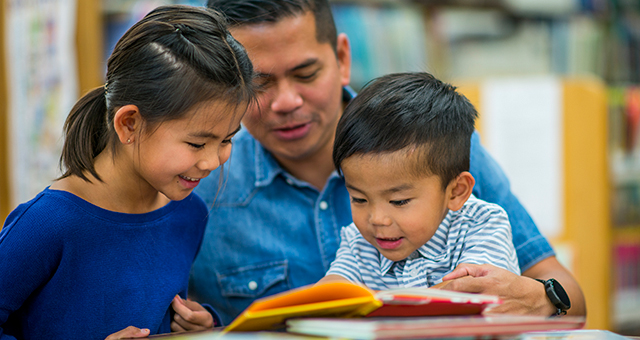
(438, 256, 586, 316)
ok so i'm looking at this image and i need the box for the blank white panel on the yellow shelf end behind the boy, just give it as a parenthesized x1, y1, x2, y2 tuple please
(480, 76, 564, 238)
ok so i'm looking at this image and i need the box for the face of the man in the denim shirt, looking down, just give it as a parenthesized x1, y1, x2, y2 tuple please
(232, 12, 351, 165)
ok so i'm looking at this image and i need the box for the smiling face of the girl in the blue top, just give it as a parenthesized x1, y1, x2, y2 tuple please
(133, 101, 244, 200)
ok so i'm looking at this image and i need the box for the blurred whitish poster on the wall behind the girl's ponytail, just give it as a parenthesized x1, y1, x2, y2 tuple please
(3, 0, 78, 209)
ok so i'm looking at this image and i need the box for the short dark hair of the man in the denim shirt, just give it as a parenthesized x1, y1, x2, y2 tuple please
(207, 0, 338, 51)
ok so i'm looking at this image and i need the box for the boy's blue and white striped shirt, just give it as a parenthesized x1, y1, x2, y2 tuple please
(327, 196, 520, 290)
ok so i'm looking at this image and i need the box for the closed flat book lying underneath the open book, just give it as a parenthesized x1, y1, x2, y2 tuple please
(287, 315, 585, 340)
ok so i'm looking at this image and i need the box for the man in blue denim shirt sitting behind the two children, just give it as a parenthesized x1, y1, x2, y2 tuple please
(190, 0, 585, 323)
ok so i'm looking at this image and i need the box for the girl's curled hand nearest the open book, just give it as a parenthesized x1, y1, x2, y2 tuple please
(171, 295, 213, 332)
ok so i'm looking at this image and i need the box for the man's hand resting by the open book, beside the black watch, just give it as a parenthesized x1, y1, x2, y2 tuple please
(437, 263, 556, 316)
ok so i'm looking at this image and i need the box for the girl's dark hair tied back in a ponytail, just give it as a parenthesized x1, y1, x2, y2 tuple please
(60, 5, 255, 181)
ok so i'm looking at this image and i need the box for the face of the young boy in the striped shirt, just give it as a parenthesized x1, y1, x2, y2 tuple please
(341, 151, 451, 261)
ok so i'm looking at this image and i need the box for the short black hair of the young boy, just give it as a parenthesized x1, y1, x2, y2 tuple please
(333, 72, 478, 188)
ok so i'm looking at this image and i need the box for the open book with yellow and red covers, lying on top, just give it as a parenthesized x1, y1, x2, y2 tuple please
(225, 282, 501, 332)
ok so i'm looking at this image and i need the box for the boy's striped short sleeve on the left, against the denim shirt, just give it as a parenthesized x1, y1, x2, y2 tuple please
(326, 223, 366, 283)
